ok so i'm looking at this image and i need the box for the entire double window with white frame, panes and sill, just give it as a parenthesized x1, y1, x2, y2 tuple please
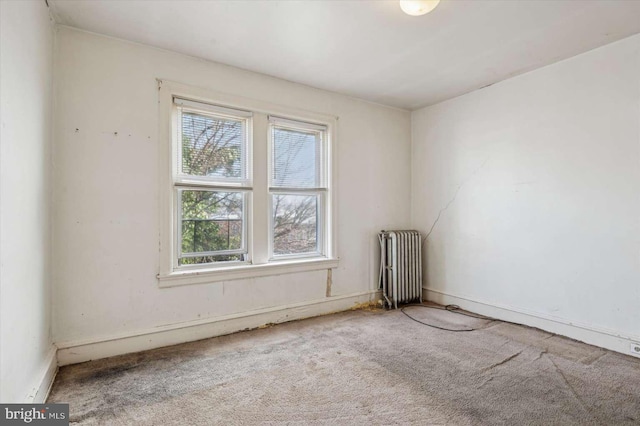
(158, 82, 337, 286)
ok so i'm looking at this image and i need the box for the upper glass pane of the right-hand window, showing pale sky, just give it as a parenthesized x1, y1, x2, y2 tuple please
(271, 126, 322, 188)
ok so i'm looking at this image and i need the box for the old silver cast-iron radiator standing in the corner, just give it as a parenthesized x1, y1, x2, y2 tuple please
(378, 231, 422, 309)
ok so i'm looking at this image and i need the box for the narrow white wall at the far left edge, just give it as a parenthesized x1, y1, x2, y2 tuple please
(0, 1, 55, 402)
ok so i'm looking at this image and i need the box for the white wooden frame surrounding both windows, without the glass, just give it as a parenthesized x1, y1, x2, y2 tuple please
(158, 80, 338, 287)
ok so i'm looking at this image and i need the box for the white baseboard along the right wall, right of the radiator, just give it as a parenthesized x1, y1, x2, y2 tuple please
(423, 288, 640, 356)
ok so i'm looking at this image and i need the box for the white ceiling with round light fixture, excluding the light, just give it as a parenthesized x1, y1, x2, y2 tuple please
(49, 0, 640, 109)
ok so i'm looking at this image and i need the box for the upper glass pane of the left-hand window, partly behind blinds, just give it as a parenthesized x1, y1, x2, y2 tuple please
(185, 112, 246, 179)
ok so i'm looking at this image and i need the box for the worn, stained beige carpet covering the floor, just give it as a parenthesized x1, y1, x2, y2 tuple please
(49, 307, 640, 425)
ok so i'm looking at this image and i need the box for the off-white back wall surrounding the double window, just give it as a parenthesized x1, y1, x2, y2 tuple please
(53, 27, 410, 363)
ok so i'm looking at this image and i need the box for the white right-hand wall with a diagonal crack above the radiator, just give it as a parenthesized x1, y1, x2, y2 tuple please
(412, 35, 640, 353)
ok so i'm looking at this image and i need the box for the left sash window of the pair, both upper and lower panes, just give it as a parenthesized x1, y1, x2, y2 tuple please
(174, 98, 252, 266)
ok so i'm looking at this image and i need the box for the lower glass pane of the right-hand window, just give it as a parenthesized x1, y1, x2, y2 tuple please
(272, 194, 318, 255)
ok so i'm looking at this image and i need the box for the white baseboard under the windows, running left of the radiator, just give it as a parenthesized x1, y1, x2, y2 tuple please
(56, 291, 380, 366)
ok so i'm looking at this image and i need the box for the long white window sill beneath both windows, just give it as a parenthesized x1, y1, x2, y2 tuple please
(158, 259, 338, 288)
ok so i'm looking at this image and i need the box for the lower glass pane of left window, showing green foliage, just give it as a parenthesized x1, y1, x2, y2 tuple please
(180, 189, 245, 264)
